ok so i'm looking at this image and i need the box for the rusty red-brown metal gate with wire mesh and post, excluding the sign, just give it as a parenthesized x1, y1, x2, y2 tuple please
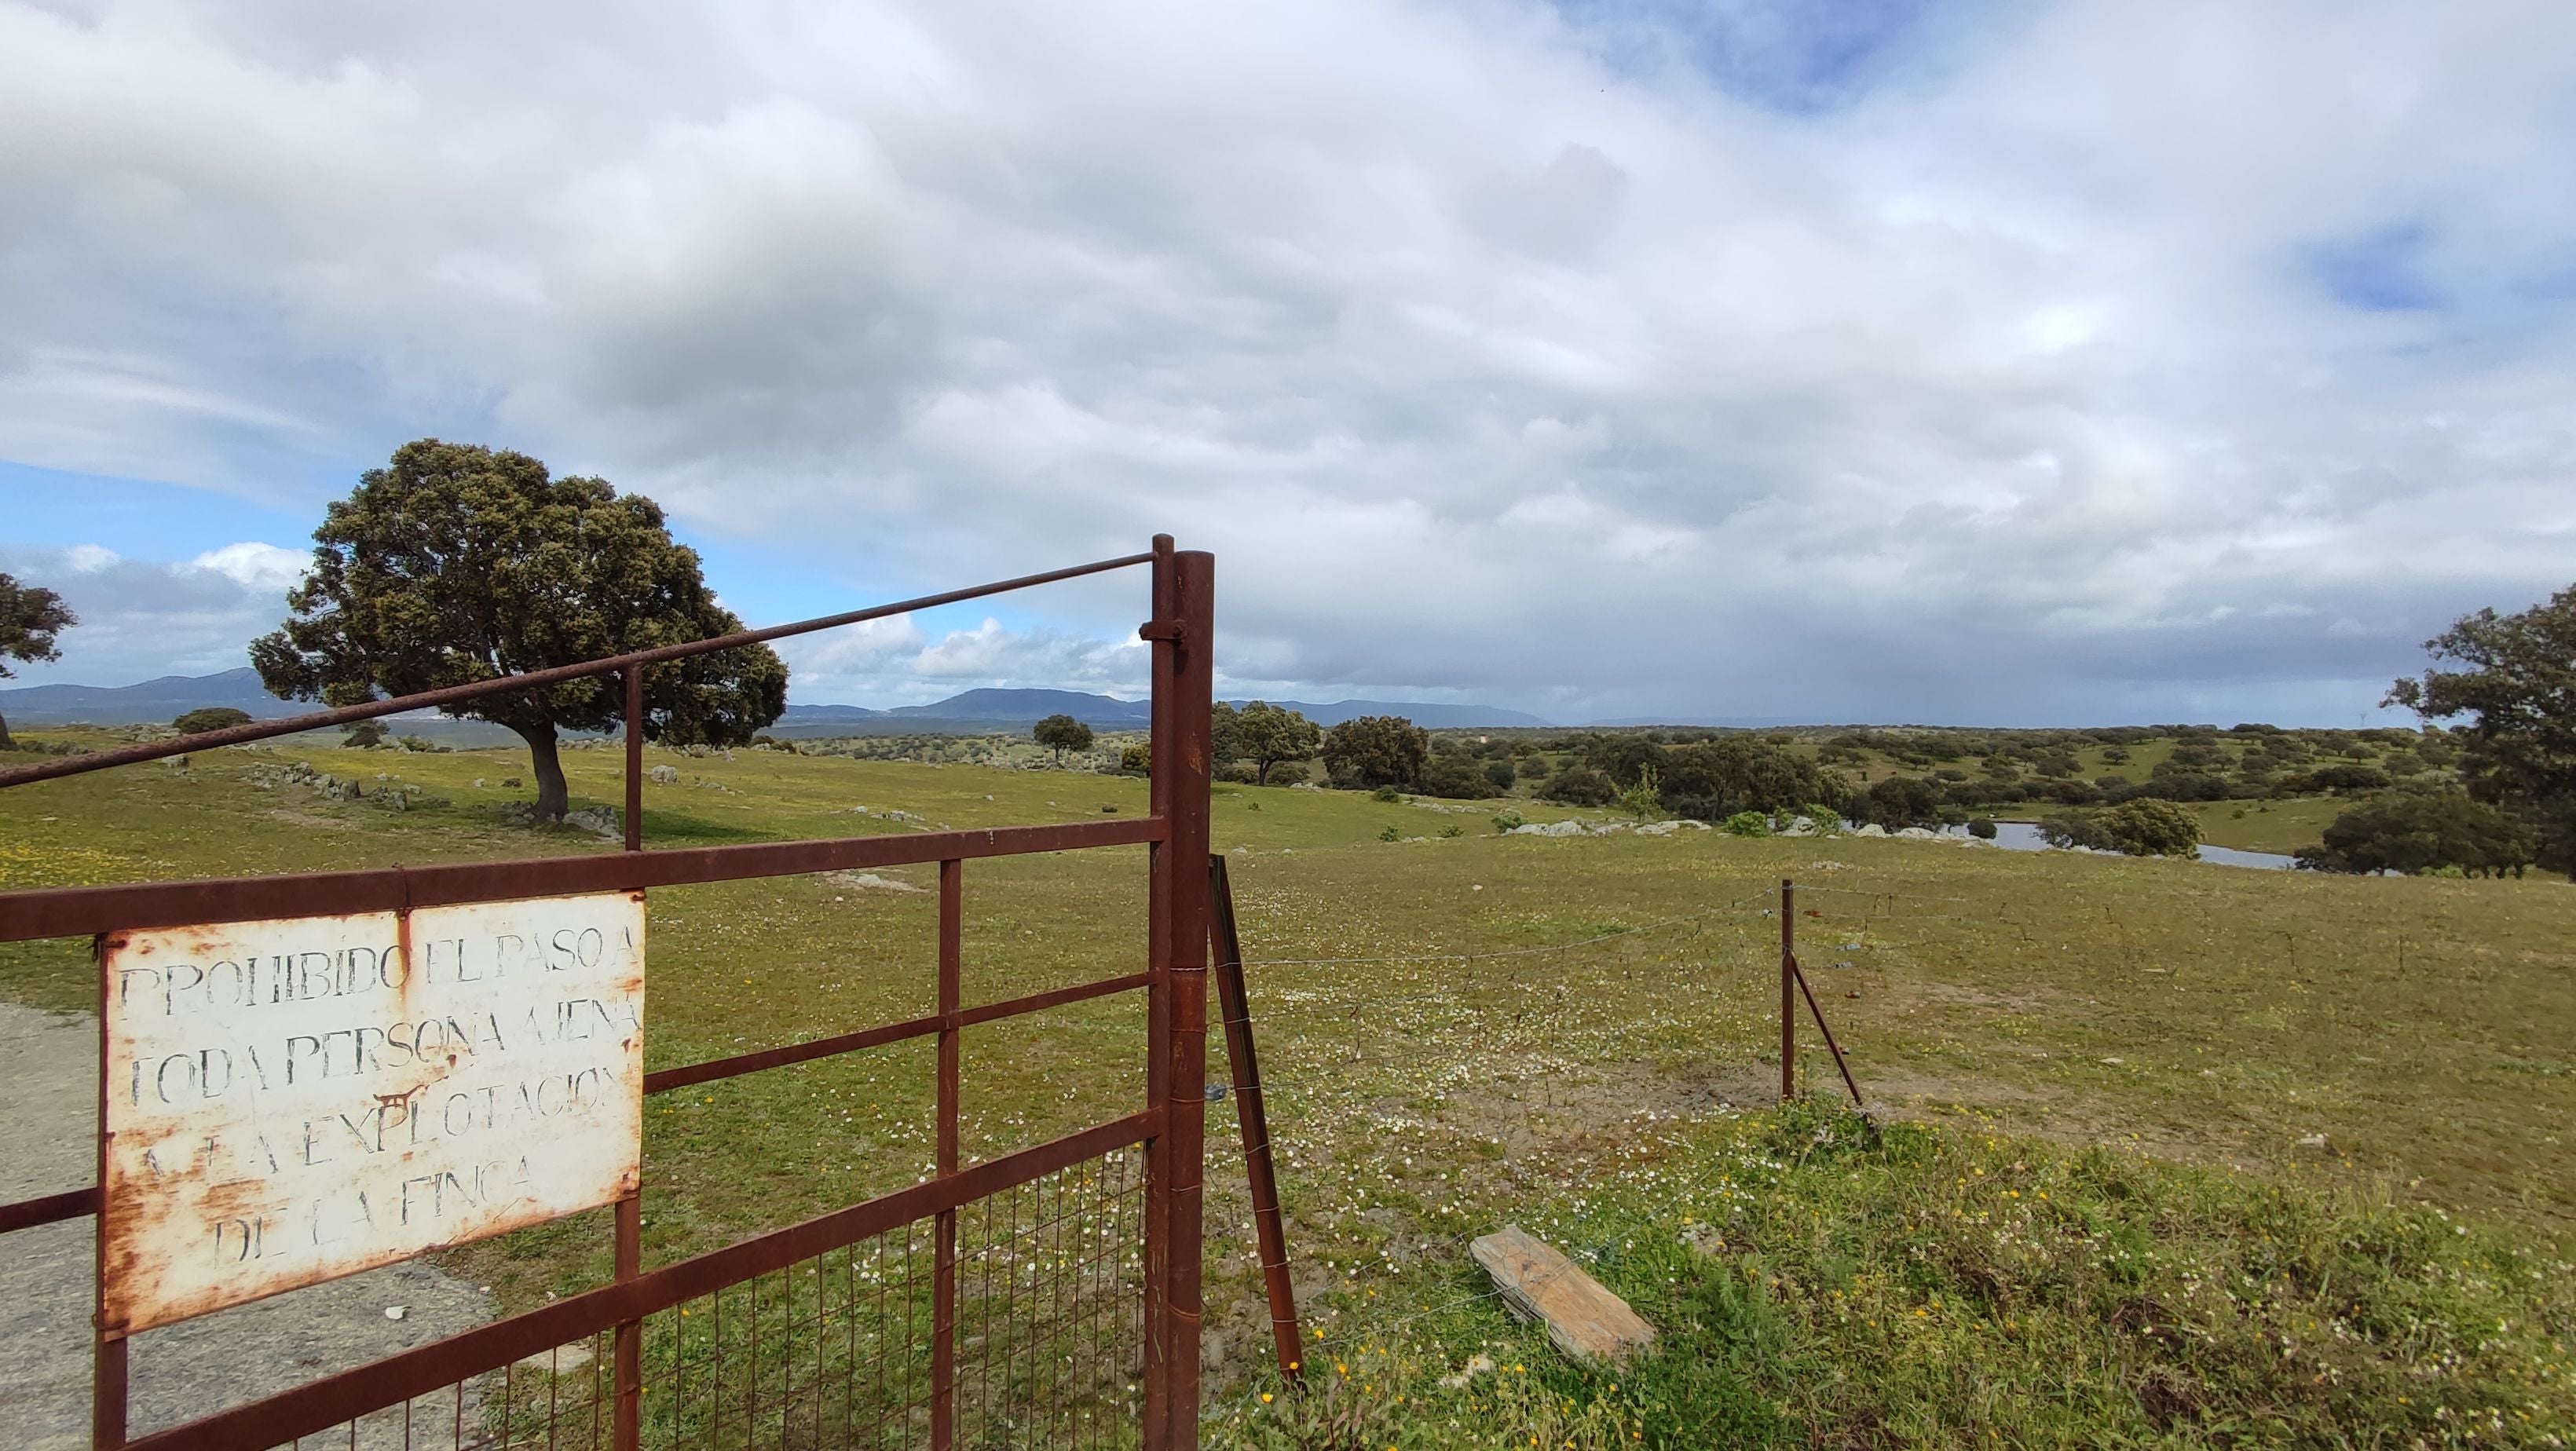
(0, 536, 1220, 1451)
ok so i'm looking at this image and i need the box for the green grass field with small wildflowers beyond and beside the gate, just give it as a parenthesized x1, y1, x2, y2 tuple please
(0, 732, 2576, 1446)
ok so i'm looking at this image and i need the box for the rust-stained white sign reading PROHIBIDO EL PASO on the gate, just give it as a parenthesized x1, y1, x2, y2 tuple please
(101, 892, 644, 1332)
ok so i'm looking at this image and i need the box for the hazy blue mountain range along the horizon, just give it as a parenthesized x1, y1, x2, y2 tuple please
(0, 667, 1548, 737)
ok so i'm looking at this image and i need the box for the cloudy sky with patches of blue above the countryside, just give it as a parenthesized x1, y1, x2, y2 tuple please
(0, 0, 2576, 724)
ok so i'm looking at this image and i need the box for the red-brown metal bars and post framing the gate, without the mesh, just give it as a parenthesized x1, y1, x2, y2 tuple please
(0, 536, 1213, 1451)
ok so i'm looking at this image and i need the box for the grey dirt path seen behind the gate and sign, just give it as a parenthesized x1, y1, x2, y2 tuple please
(0, 1003, 492, 1451)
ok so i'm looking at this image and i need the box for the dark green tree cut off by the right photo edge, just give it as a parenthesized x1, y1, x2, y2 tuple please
(2385, 585, 2576, 874)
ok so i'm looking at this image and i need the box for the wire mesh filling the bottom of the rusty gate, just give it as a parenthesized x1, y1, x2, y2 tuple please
(246, 1147, 1143, 1451)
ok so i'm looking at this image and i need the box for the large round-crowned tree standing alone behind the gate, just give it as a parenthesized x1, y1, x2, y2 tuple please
(250, 438, 789, 820)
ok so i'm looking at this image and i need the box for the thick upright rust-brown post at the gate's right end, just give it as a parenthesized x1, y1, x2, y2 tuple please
(1141, 533, 1216, 1451)
